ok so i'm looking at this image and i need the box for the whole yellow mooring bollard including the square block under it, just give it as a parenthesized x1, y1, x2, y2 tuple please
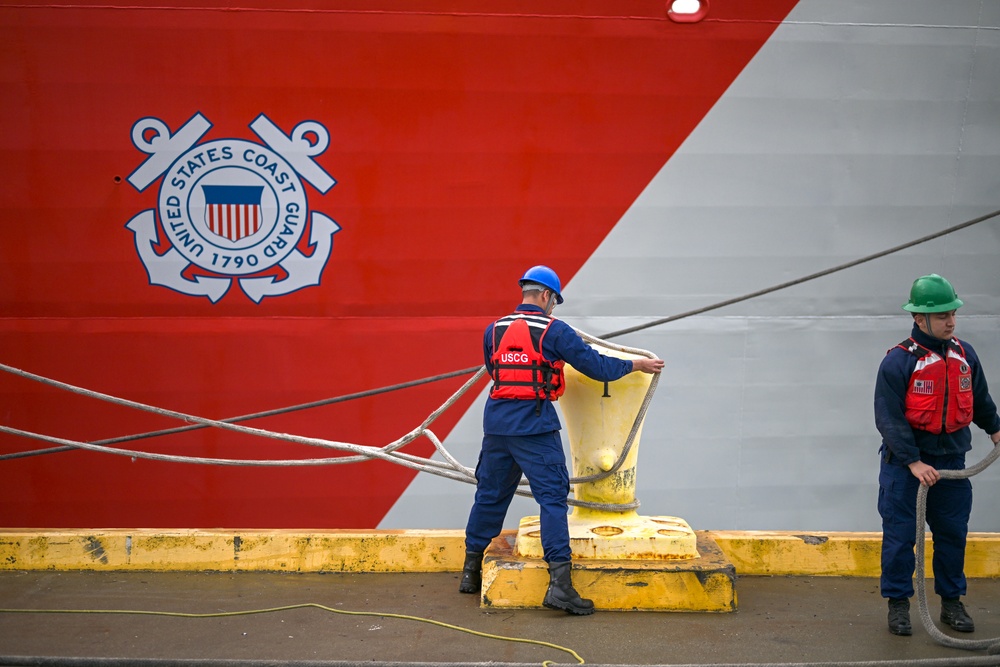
(480, 345, 736, 612)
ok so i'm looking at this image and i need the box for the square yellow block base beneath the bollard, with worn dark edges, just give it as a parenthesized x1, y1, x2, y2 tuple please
(480, 531, 736, 612)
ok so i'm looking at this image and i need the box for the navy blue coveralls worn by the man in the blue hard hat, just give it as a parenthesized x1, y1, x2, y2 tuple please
(465, 304, 632, 563)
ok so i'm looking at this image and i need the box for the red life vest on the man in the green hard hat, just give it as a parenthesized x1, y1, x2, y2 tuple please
(897, 338, 973, 433)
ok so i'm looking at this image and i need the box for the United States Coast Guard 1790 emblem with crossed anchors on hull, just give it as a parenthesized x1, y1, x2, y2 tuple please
(126, 113, 340, 303)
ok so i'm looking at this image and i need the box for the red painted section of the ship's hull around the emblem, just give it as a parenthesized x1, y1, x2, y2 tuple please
(0, 0, 795, 528)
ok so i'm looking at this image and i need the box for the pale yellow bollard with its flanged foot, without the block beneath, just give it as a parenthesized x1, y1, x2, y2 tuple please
(515, 346, 699, 560)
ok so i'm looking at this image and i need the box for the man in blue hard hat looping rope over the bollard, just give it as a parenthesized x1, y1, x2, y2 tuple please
(459, 266, 663, 615)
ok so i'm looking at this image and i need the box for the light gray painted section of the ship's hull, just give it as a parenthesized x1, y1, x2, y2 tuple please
(379, 0, 1000, 532)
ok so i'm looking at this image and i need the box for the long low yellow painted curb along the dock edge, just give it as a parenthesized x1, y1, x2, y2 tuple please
(0, 528, 1000, 578)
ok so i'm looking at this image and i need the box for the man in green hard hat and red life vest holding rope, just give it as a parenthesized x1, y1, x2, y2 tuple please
(875, 273, 1000, 635)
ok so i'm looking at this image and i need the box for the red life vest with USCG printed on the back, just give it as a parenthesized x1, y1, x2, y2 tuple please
(490, 313, 566, 405)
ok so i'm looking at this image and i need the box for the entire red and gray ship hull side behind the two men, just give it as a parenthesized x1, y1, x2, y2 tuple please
(0, 0, 1000, 531)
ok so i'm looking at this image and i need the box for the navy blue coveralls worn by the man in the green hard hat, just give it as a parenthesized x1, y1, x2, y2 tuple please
(875, 324, 1000, 599)
